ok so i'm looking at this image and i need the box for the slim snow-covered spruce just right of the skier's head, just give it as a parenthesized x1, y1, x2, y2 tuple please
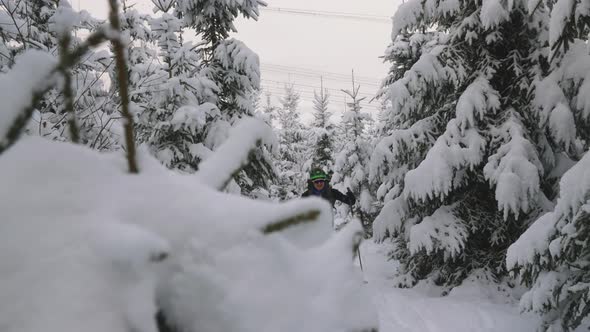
(332, 73, 375, 234)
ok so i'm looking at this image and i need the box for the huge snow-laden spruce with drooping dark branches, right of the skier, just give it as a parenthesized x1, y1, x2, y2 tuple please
(371, 0, 581, 285)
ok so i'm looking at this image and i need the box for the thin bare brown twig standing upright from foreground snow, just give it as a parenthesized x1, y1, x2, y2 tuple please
(109, 0, 139, 173)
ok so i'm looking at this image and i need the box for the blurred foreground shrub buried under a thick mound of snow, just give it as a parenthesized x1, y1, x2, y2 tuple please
(0, 0, 376, 332)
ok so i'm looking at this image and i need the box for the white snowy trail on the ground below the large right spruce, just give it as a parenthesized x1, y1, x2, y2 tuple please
(361, 241, 537, 332)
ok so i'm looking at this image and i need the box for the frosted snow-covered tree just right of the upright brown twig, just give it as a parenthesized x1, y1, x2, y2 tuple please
(136, 8, 219, 172)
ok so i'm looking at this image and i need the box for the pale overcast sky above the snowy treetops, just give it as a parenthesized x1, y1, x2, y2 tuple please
(77, 0, 401, 121)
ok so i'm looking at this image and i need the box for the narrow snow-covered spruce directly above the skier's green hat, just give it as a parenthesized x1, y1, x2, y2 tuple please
(312, 80, 334, 171)
